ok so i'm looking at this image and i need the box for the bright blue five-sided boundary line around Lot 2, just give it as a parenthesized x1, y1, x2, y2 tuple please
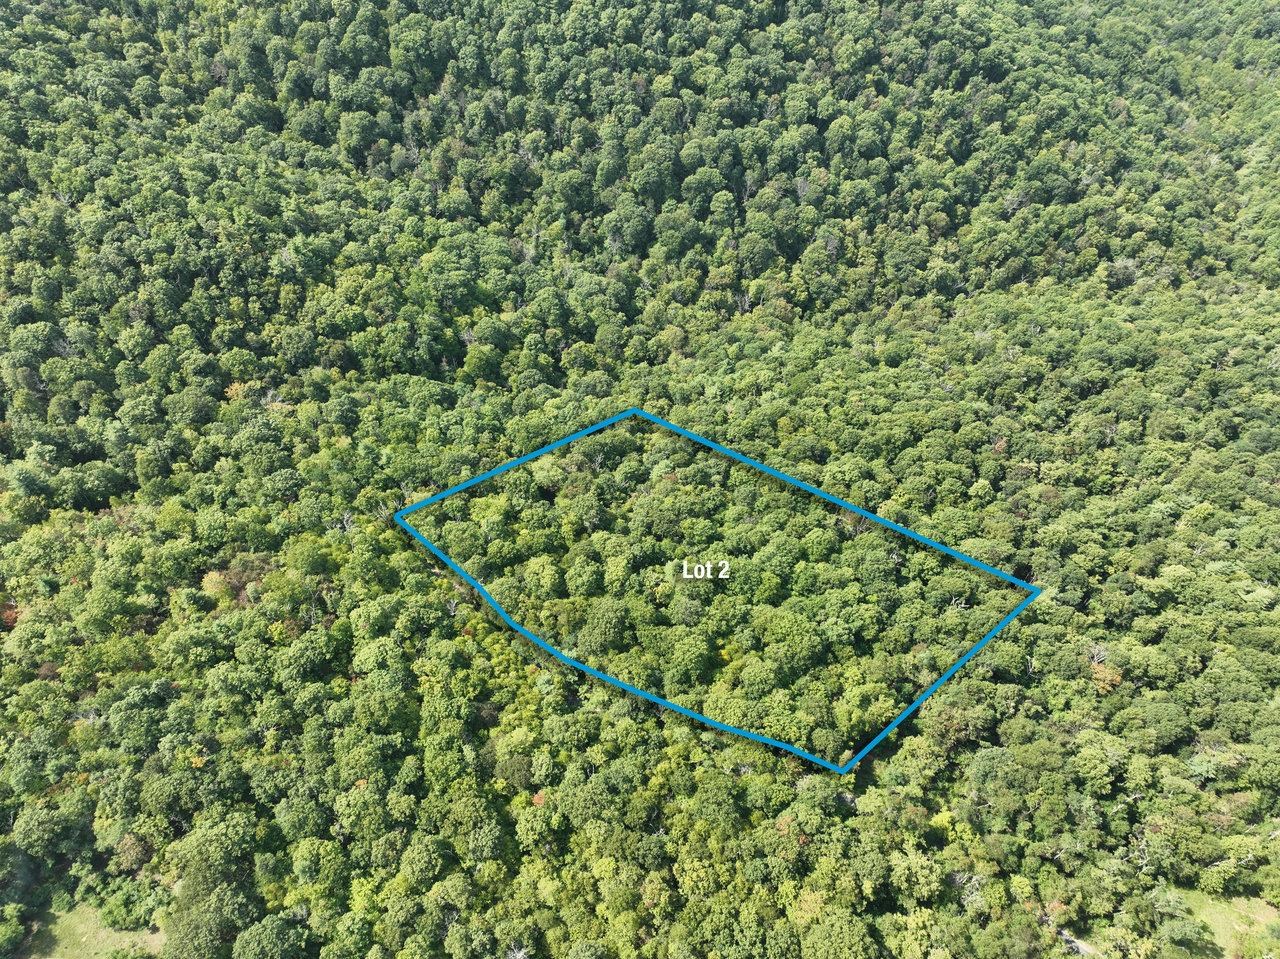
(396, 407, 1042, 773)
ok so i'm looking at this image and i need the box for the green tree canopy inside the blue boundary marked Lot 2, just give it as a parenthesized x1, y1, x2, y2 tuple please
(410, 420, 1029, 766)
